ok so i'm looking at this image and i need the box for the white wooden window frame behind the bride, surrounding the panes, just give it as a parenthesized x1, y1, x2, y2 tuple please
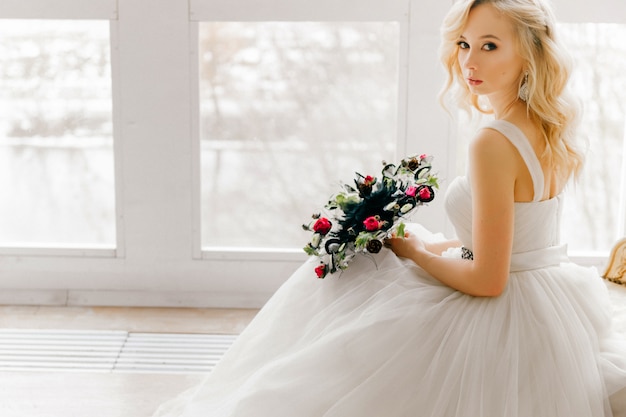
(0, 0, 626, 308)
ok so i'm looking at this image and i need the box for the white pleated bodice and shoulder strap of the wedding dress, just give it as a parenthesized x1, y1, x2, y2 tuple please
(445, 120, 566, 270)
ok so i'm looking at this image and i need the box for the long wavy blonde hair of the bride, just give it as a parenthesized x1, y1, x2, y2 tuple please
(440, 0, 583, 178)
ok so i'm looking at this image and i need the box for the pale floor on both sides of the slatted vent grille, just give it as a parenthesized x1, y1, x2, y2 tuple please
(0, 283, 626, 417)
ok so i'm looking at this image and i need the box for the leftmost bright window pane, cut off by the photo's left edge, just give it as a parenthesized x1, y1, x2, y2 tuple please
(0, 20, 115, 246)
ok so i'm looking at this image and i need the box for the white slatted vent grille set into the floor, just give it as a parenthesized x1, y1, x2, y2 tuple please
(0, 329, 237, 373)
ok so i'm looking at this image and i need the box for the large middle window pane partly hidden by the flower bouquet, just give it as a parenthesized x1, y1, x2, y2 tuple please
(200, 22, 399, 247)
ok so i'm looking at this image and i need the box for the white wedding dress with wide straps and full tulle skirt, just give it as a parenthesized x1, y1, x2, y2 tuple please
(157, 121, 626, 417)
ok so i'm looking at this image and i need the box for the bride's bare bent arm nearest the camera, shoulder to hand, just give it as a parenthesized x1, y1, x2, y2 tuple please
(389, 129, 520, 296)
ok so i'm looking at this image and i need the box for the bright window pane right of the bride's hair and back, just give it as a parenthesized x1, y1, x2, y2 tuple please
(560, 23, 626, 254)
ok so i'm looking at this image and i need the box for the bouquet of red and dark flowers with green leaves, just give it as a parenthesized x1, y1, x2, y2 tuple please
(302, 155, 439, 278)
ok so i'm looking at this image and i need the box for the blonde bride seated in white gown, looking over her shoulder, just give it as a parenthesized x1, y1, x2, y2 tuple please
(157, 0, 626, 417)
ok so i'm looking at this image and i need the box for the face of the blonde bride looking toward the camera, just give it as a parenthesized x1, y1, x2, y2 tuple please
(458, 4, 524, 98)
